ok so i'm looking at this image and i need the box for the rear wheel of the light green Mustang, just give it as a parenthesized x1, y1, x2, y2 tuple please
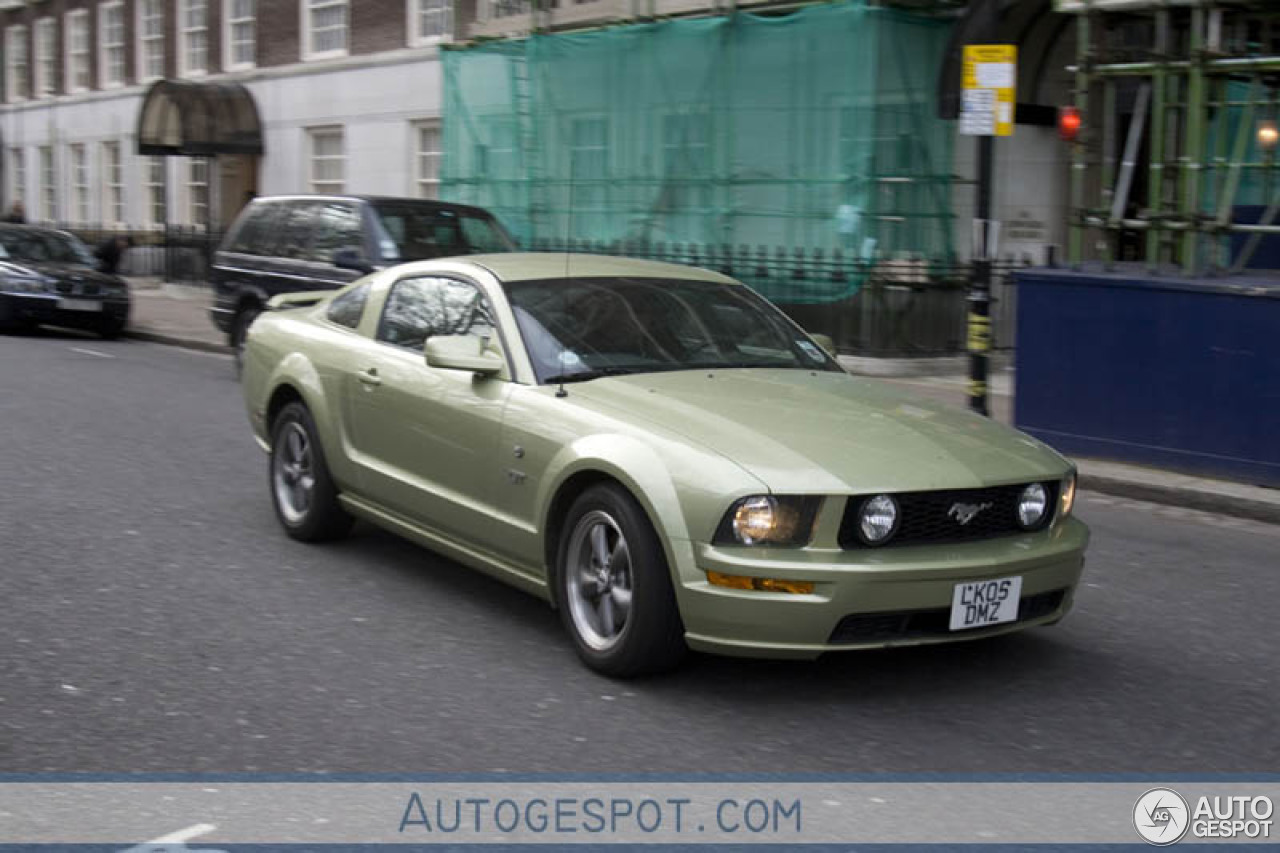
(270, 402, 352, 542)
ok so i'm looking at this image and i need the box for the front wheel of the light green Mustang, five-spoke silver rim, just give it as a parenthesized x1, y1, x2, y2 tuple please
(556, 484, 686, 678)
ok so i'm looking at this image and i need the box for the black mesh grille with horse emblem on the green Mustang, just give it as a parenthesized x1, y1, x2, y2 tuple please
(840, 483, 1057, 548)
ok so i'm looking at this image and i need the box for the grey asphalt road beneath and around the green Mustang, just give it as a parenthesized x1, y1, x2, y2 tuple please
(0, 333, 1280, 774)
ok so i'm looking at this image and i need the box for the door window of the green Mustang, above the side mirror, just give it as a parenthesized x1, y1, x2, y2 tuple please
(378, 275, 494, 351)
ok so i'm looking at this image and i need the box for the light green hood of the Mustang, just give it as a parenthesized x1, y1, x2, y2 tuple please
(570, 369, 1069, 494)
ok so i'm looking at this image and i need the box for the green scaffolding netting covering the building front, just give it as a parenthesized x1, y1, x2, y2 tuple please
(440, 0, 952, 302)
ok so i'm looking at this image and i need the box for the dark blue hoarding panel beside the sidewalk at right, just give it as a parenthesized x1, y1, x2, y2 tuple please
(1014, 269, 1280, 487)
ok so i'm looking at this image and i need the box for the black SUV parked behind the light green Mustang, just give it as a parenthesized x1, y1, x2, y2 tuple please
(210, 196, 516, 360)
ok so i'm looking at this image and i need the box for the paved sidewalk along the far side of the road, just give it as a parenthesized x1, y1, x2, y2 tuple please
(127, 278, 1280, 524)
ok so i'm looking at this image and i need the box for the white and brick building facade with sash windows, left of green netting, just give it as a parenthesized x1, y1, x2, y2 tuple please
(0, 0, 456, 227)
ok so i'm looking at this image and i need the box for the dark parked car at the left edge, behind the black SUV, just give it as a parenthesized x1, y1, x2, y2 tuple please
(0, 224, 129, 338)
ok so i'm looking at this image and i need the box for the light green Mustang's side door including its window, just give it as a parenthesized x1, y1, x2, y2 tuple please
(344, 275, 511, 547)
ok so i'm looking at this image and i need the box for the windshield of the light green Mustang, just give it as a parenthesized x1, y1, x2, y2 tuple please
(506, 278, 840, 383)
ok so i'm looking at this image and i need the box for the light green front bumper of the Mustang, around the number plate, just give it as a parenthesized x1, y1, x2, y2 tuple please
(676, 517, 1089, 658)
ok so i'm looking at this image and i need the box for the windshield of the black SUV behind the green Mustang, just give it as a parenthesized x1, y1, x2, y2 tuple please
(372, 202, 516, 264)
